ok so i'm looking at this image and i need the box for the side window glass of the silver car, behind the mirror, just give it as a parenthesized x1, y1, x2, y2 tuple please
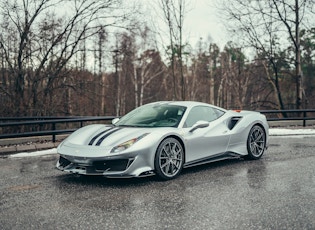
(184, 106, 224, 127)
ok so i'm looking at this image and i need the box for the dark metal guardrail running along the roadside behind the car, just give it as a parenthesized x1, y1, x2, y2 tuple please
(0, 109, 315, 142)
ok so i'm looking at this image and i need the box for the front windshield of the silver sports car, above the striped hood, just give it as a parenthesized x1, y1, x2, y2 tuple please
(115, 103, 186, 127)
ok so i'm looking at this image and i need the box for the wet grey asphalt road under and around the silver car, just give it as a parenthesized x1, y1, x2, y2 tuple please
(0, 136, 315, 230)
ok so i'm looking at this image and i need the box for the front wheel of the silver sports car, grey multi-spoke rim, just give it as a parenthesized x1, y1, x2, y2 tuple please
(154, 138, 184, 180)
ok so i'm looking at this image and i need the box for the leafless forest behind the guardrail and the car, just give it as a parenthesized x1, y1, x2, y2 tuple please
(0, 0, 315, 117)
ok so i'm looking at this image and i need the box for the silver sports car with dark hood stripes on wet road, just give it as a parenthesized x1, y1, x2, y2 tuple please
(56, 101, 268, 180)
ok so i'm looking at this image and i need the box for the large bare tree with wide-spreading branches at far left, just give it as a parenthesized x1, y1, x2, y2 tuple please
(0, 0, 133, 115)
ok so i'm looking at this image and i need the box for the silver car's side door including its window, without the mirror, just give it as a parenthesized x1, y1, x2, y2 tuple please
(184, 106, 230, 163)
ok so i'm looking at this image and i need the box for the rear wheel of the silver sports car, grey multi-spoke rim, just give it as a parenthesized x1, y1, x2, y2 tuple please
(247, 125, 266, 160)
